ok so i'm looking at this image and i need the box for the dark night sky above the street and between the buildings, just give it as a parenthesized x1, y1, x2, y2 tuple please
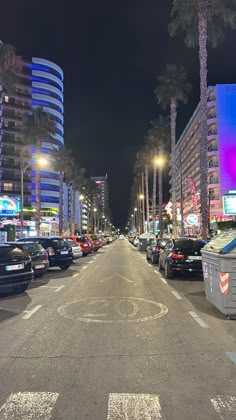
(0, 0, 236, 225)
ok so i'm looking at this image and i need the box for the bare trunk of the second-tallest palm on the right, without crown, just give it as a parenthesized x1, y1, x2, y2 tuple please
(170, 98, 178, 236)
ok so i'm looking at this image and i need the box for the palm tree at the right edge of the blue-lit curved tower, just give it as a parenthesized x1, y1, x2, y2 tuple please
(53, 146, 73, 235)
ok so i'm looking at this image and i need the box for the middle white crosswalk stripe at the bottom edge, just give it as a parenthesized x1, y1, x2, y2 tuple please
(107, 394, 162, 420)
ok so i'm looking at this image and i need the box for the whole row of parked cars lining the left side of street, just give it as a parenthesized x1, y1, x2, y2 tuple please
(0, 235, 113, 293)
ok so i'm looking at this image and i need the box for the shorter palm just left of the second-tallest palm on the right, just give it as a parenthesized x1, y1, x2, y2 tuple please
(152, 115, 170, 238)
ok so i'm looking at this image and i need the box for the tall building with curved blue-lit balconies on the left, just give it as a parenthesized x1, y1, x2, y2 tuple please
(0, 57, 64, 225)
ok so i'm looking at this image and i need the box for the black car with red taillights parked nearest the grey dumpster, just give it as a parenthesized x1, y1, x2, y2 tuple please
(159, 238, 206, 279)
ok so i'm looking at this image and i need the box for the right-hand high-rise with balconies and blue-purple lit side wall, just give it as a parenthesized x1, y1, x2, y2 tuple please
(172, 84, 236, 233)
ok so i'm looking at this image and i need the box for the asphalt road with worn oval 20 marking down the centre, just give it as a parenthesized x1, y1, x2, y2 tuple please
(0, 241, 236, 420)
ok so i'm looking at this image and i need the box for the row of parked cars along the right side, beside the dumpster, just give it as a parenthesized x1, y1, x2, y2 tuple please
(130, 237, 206, 279)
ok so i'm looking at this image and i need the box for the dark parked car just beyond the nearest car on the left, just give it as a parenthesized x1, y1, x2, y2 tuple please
(9, 241, 49, 276)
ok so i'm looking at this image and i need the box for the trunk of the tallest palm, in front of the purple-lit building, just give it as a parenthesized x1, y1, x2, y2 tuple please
(198, 13, 209, 239)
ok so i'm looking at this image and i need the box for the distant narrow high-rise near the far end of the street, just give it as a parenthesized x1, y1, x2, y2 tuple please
(92, 175, 109, 215)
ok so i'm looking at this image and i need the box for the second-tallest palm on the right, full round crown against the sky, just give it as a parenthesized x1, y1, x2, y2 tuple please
(154, 64, 191, 236)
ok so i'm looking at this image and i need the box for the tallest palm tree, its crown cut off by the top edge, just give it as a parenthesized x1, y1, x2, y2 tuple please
(169, 0, 236, 239)
